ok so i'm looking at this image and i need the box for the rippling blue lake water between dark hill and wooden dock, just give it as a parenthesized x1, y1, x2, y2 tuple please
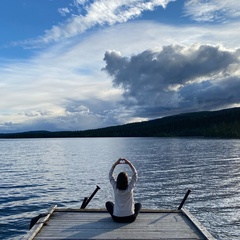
(0, 138, 240, 240)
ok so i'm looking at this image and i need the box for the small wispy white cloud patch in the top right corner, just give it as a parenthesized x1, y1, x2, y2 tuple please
(185, 0, 240, 22)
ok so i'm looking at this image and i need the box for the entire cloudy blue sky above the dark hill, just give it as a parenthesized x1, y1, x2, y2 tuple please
(0, 0, 240, 133)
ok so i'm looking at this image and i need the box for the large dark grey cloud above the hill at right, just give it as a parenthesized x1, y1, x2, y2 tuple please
(104, 45, 240, 118)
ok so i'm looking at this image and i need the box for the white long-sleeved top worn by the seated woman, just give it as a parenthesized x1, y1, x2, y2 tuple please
(109, 166, 138, 217)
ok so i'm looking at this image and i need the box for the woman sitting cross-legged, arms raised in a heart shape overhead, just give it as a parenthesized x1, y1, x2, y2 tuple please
(106, 158, 142, 223)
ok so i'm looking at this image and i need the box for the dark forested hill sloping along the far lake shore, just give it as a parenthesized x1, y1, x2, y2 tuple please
(0, 108, 240, 138)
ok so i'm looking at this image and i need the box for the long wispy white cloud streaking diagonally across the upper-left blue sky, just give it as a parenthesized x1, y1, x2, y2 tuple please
(22, 0, 176, 45)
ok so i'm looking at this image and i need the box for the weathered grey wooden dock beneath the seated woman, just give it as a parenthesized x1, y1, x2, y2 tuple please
(24, 206, 214, 240)
